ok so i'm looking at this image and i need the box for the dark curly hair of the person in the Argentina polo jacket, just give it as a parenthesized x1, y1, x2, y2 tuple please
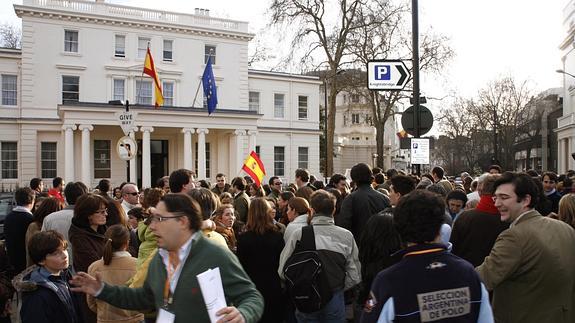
(393, 190, 445, 243)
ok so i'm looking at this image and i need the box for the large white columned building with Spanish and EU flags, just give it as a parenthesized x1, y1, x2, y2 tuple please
(0, 0, 320, 189)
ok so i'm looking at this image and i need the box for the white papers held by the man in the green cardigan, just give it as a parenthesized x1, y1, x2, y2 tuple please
(196, 267, 227, 323)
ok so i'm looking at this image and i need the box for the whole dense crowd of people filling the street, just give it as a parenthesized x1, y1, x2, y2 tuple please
(0, 163, 575, 323)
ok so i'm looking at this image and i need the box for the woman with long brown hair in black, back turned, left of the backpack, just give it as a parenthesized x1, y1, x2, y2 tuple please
(237, 197, 287, 322)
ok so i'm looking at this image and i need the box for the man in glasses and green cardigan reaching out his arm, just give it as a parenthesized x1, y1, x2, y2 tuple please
(71, 194, 264, 322)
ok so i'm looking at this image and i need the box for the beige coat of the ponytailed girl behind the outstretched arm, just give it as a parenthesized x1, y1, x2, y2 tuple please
(87, 252, 144, 323)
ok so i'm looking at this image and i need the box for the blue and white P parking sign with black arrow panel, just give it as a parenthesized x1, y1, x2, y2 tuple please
(367, 60, 411, 91)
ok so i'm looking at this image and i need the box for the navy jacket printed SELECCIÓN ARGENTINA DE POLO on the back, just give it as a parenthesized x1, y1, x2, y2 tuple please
(361, 244, 493, 323)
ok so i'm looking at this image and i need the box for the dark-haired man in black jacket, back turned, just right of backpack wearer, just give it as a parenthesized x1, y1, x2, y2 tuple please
(336, 163, 390, 242)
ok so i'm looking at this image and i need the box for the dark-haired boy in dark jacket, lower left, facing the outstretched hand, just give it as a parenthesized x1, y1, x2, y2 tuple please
(13, 231, 80, 323)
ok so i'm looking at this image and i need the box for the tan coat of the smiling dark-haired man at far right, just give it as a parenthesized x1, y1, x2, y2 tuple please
(477, 210, 575, 323)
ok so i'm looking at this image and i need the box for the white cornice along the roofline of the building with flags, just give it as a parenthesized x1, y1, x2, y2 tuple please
(23, 0, 248, 33)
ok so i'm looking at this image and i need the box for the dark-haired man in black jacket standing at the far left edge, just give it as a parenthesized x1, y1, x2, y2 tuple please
(4, 187, 36, 273)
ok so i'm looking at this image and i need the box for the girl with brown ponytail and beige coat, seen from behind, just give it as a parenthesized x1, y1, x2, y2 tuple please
(87, 224, 144, 323)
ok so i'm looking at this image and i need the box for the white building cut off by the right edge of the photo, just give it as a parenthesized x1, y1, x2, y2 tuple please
(556, 0, 575, 174)
